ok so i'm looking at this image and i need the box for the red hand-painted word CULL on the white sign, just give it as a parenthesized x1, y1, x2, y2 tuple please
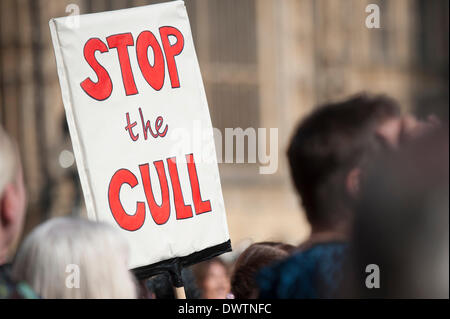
(108, 154, 211, 231)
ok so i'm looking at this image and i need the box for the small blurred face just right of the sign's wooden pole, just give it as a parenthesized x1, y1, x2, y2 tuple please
(193, 257, 230, 299)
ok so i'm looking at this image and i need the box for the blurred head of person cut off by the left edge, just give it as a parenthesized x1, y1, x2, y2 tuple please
(0, 126, 26, 264)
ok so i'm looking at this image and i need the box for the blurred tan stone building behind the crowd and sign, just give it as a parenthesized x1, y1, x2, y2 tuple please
(0, 0, 449, 247)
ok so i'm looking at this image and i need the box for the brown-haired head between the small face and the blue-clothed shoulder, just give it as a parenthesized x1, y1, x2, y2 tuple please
(231, 242, 294, 299)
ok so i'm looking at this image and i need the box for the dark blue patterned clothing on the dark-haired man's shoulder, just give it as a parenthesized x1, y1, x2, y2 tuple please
(257, 242, 347, 299)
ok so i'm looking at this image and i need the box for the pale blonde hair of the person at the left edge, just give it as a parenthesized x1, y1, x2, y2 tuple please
(0, 125, 18, 198)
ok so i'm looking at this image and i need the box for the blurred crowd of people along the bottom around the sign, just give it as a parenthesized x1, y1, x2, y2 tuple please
(0, 94, 449, 299)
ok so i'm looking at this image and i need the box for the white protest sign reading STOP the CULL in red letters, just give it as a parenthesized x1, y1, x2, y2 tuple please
(50, 1, 230, 268)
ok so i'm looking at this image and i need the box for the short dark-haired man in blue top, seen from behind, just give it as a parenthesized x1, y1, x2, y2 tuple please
(258, 95, 401, 298)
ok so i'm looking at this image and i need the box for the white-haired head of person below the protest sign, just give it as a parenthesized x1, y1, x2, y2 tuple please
(12, 217, 137, 299)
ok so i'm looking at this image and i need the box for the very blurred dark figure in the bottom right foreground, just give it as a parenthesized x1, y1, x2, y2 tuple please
(342, 125, 449, 299)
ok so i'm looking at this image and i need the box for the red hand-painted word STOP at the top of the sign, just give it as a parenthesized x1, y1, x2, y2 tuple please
(80, 26, 184, 101)
